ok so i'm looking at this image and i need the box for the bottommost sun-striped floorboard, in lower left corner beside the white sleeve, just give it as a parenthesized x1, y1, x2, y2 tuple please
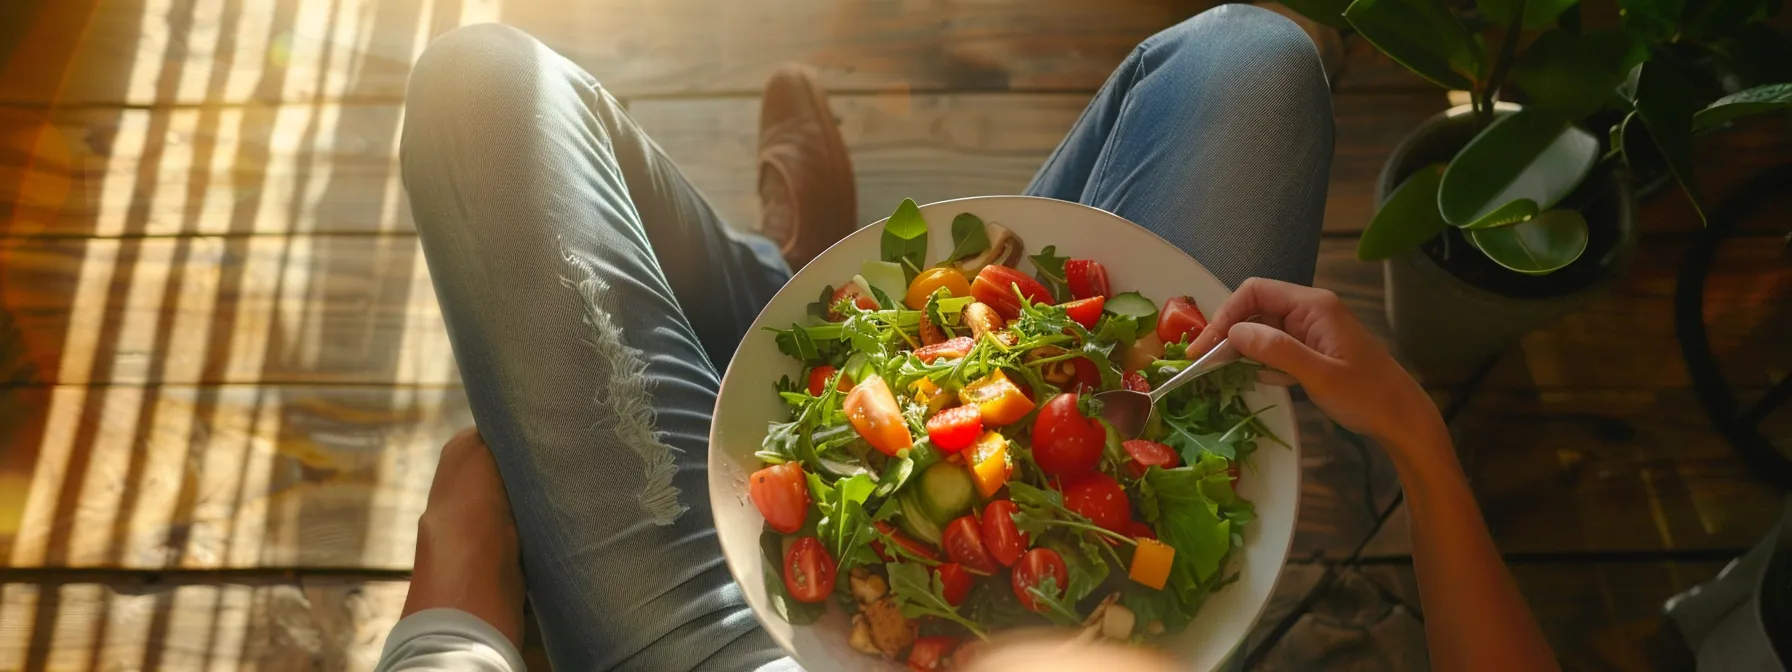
(0, 579, 410, 670)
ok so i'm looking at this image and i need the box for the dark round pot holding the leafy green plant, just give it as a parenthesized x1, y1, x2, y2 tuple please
(1378, 106, 1636, 380)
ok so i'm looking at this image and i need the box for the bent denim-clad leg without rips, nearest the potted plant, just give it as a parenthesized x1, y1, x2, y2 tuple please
(1027, 5, 1331, 287)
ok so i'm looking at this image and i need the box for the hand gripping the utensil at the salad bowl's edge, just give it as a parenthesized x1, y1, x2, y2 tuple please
(1188, 278, 1443, 446)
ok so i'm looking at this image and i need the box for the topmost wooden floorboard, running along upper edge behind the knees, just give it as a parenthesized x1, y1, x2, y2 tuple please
(0, 0, 1211, 106)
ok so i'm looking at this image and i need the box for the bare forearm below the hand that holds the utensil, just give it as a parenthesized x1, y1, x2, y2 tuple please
(1387, 421, 1559, 670)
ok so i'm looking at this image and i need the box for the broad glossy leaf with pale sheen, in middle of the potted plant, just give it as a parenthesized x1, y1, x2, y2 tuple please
(1437, 109, 1598, 226)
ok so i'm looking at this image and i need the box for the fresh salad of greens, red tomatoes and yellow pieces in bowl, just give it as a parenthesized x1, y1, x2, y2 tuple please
(747, 201, 1279, 670)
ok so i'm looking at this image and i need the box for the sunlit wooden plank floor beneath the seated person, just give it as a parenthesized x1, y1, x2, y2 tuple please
(0, 0, 1792, 670)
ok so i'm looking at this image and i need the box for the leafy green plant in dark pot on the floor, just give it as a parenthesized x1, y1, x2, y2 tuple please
(1285, 0, 1792, 376)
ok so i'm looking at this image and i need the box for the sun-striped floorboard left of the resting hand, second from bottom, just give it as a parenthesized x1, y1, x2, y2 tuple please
(0, 385, 473, 569)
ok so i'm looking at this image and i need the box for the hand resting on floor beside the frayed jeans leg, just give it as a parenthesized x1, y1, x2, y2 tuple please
(403, 428, 523, 645)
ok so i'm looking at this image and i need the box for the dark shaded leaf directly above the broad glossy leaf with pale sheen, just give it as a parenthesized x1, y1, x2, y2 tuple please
(1512, 30, 1645, 120)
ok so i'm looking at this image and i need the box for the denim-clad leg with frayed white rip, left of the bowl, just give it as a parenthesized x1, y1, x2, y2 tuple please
(401, 25, 788, 670)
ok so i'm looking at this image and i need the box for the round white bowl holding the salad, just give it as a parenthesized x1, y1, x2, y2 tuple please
(710, 195, 1301, 670)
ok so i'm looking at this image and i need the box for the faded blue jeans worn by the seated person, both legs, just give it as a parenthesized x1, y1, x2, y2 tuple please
(401, 5, 1331, 670)
